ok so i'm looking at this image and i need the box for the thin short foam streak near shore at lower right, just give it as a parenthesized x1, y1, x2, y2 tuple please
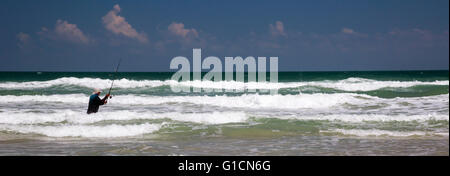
(321, 129, 448, 137)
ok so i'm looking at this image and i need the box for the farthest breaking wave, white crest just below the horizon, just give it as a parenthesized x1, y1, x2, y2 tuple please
(0, 77, 449, 91)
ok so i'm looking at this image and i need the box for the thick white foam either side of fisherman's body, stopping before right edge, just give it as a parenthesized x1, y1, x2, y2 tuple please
(0, 93, 376, 109)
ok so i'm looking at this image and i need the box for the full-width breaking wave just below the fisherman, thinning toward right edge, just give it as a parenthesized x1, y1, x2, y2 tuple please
(0, 110, 449, 125)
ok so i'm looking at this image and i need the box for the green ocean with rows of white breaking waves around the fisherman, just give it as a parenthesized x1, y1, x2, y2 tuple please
(0, 71, 449, 156)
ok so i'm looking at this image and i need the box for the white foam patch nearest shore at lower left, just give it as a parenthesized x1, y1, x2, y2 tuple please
(0, 123, 161, 138)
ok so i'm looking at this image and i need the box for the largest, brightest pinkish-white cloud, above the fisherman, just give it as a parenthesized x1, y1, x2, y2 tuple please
(102, 4, 148, 43)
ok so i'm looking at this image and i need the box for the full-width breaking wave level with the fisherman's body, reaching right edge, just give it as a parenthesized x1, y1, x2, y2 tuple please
(0, 93, 449, 109)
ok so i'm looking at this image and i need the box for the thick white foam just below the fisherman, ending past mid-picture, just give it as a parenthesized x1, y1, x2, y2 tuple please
(0, 110, 248, 125)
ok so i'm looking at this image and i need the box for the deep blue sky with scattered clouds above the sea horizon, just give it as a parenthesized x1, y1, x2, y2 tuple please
(0, 0, 449, 72)
